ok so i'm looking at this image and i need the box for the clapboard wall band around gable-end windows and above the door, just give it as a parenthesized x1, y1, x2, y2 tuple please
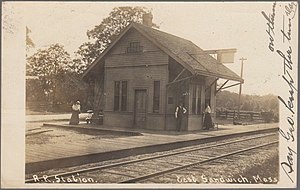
(105, 65, 168, 113)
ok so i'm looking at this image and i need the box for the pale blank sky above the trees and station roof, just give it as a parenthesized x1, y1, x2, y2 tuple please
(4, 2, 297, 95)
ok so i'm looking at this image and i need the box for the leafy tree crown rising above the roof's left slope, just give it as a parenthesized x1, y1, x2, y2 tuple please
(75, 6, 158, 66)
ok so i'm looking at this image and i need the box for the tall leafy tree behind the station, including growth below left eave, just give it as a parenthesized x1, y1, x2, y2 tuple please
(73, 6, 158, 112)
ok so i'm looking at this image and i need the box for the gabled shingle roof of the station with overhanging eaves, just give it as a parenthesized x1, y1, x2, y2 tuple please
(84, 23, 243, 82)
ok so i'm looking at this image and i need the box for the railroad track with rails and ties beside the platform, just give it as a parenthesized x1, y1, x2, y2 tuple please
(25, 133, 278, 183)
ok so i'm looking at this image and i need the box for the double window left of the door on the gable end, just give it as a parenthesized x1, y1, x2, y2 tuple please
(114, 81, 127, 111)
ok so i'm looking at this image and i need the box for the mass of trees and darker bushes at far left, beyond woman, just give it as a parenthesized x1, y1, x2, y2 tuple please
(26, 44, 86, 107)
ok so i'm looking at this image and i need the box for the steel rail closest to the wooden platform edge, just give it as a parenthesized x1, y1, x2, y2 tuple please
(25, 133, 277, 183)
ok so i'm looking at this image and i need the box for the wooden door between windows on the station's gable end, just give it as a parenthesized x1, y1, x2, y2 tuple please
(134, 90, 147, 128)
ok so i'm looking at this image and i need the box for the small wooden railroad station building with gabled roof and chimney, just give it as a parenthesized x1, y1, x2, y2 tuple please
(83, 14, 243, 130)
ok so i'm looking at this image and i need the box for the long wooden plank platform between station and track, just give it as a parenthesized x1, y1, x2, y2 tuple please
(26, 123, 278, 173)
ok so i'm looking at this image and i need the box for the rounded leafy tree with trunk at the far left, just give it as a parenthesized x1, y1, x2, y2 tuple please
(26, 44, 73, 102)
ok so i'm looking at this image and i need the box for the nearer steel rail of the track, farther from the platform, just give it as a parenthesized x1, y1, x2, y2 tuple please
(119, 141, 279, 183)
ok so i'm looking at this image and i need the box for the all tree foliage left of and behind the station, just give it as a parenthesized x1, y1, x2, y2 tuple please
(26, 6, 158, 113)
